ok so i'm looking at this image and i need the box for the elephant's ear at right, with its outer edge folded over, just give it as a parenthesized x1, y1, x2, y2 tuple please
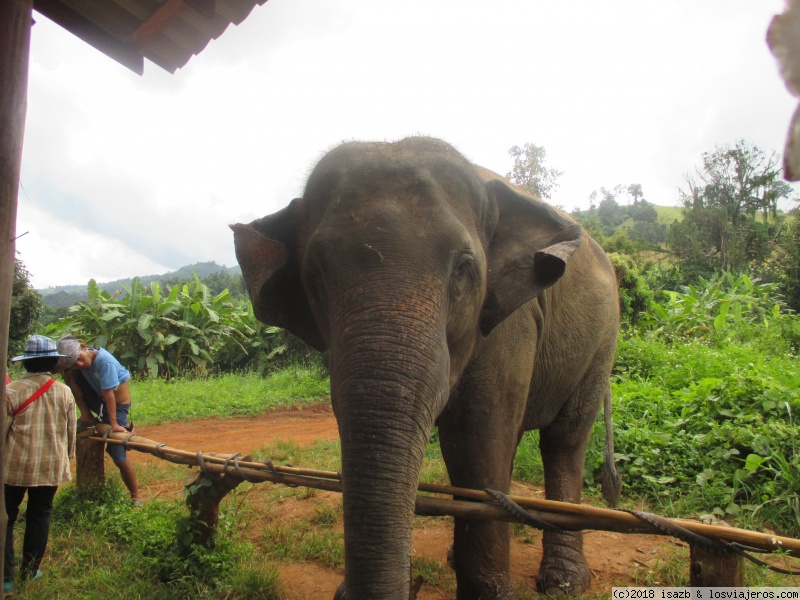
(480, 179, 582, 335)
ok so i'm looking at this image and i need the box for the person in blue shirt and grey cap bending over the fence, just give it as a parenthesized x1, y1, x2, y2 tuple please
(58, 335, 142, 507)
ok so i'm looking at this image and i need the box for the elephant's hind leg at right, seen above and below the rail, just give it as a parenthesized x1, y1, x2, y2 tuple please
(537, 428, 591, 595)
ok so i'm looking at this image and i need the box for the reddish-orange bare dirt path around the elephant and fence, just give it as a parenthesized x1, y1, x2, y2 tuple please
(130, 405, 688, 600)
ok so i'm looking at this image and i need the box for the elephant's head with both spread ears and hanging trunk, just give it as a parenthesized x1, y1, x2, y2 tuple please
(232, 138, 582, 600)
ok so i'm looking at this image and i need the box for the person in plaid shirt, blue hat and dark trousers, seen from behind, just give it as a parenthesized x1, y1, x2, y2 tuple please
(3, 335, 76, 593)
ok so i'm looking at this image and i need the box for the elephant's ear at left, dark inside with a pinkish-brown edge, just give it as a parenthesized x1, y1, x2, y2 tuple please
(230, 199, 325, 352)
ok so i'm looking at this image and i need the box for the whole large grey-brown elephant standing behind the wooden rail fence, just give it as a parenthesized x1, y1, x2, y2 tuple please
(232, 138, 618, 600)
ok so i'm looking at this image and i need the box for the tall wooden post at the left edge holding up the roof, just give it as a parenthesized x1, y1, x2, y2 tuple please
(0, 0, 33, 580)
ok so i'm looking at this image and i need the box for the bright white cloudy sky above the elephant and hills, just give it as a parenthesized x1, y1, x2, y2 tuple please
(16, 0, 800, 289)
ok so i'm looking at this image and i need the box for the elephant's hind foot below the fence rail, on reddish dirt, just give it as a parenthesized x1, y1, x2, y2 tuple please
(536, 534, 592, 596)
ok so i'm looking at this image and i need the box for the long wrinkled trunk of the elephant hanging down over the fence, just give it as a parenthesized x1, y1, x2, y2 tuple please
(331, 290, 449, 600)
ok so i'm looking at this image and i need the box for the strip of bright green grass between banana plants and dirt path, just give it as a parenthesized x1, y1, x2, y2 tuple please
(131, 367, 330, 425)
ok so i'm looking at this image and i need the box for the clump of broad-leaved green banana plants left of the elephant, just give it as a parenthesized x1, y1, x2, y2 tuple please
(45, 275, 300, 377)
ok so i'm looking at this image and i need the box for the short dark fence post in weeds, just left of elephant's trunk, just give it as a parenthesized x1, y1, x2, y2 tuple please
(183, 454, 250, 548)
